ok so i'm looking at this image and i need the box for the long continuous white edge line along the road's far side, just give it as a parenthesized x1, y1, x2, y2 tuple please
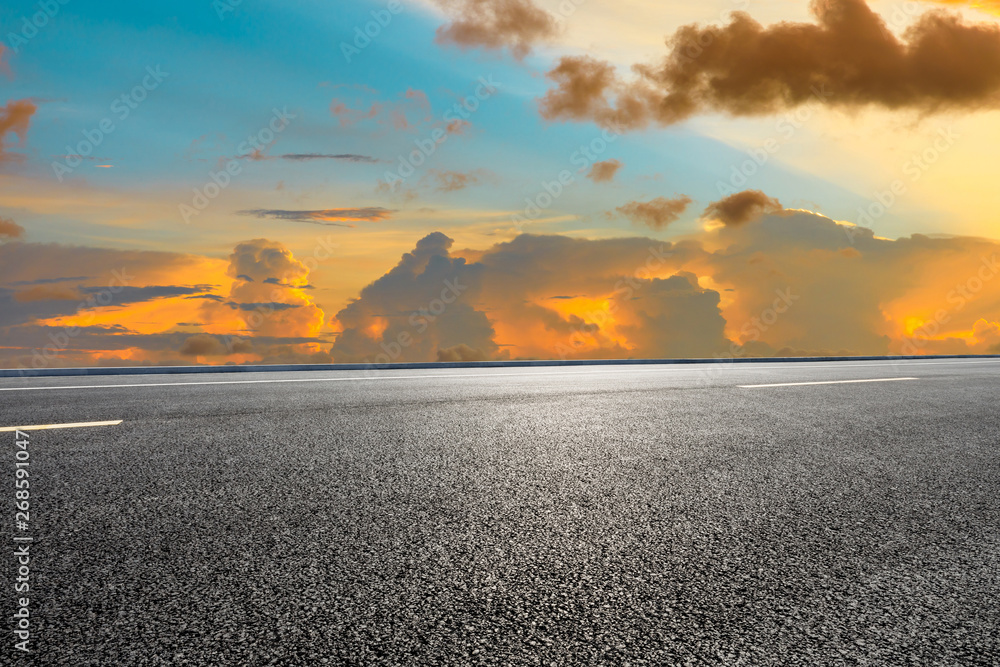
(0, 359, 1000, 391)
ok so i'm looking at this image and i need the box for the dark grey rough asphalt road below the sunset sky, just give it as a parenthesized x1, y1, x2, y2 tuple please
(0, 361, 1000, 666)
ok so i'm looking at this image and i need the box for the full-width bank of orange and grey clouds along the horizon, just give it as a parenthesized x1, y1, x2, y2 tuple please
(9, 210, 1000, 367)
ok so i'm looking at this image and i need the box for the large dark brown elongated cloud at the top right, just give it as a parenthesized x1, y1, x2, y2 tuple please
(540, 0, 1000, 131)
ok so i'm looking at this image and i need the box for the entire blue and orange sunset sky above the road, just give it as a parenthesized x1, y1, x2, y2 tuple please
(0, 0, 1000, 368)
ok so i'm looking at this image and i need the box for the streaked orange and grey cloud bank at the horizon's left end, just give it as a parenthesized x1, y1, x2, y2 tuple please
(0, 239, 332, 368)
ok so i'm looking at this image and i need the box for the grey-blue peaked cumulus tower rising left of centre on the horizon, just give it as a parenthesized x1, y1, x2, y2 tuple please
(332, 232, 498, 363)
